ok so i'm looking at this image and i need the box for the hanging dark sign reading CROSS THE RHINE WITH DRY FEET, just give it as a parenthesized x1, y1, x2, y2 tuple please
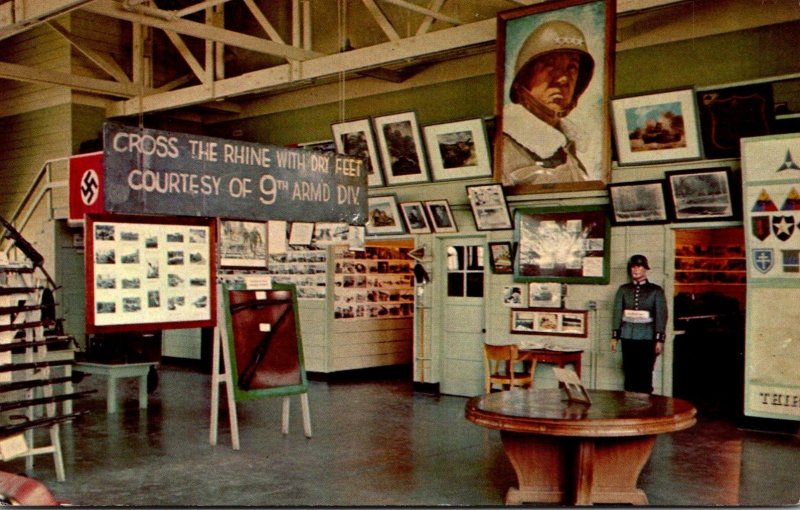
(103, 123, 367, 225)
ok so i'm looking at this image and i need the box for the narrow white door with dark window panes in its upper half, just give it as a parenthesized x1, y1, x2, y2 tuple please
(439, 237, 486, 396)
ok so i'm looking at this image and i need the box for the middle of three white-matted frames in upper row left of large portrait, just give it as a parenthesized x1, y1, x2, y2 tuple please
(374, 112, 430, 185)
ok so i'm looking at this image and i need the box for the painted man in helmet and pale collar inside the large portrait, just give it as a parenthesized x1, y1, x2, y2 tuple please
(502, 21, 594, 185)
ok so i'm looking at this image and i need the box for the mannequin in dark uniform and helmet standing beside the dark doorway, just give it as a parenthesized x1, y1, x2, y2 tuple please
(611, 255, 667, 393)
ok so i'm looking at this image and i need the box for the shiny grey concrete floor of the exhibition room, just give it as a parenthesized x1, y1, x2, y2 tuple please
(1, 366, 800, 507)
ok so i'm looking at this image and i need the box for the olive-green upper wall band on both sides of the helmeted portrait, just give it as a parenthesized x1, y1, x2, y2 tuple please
(207, 22, 800, 145)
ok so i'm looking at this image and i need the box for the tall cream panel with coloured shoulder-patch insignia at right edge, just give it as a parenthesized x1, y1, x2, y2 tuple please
(741, 134, 800, 421)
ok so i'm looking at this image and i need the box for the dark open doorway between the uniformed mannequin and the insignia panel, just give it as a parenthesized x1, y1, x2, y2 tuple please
(672, 227, 747, 417)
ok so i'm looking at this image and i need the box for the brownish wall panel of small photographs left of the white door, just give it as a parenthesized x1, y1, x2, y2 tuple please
(333, 246, 414, 320)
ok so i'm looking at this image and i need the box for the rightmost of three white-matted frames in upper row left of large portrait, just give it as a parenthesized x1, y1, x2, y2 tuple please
(422, 119, 492, 181)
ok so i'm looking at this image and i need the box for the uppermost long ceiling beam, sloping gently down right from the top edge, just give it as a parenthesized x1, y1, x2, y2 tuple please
(84, 0, 320, 60)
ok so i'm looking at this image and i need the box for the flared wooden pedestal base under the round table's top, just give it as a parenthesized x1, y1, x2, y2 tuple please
(501, 431, 656, 505)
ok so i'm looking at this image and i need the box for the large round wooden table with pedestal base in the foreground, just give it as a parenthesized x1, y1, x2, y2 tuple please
(465, 389, 697, 505)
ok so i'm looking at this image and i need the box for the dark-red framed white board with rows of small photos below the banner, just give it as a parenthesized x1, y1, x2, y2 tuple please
(85, 215, 216, 333)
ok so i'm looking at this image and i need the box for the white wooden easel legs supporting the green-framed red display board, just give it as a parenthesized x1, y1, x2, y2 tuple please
(209, 285, 311, 450)
